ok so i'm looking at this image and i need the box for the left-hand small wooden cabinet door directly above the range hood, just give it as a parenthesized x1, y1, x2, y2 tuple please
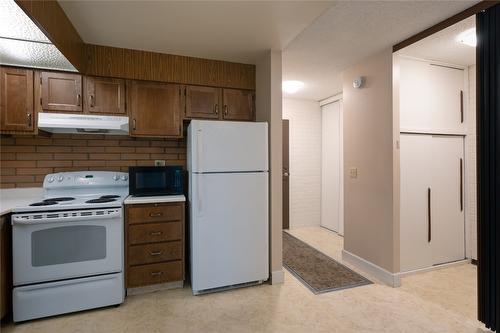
(41, 72, 83, 112)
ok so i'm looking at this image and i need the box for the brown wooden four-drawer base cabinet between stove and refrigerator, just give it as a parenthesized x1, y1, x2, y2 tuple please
(125, 202, 185, 288)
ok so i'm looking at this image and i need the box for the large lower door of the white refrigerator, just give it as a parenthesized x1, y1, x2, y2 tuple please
(190, 172, 269, 293)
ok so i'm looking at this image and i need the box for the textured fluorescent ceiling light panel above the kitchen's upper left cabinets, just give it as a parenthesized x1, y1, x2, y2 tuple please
(0, 0, 76, 71)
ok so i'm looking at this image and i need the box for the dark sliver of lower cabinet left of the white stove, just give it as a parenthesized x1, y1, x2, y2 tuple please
(0, 215, 12, 319)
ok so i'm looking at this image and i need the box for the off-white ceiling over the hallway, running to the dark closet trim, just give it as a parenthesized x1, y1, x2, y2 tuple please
(283, 1, 478, 100)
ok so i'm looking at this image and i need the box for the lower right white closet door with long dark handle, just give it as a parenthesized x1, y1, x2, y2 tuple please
(431, 136, 465, 264)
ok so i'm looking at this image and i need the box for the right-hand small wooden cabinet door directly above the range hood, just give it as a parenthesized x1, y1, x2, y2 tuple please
(84, 77, 126, 115)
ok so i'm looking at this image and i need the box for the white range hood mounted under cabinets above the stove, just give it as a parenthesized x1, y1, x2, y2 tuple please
(38, 112, 129, 135)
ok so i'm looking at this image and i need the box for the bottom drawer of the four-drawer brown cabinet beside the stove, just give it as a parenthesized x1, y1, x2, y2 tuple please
(127, 260, 184, 288)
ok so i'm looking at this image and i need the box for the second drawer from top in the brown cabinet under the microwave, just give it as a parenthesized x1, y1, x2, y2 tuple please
(128, 222, 182, 245)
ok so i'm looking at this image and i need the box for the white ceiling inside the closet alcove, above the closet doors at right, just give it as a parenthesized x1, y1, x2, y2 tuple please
(400, 16, 476, 66)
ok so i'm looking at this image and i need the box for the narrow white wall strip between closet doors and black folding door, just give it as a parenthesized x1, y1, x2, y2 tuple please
(465, 65, 477, 259)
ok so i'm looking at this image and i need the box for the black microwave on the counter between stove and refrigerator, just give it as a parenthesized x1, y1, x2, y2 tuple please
(128, 166, 184, 196)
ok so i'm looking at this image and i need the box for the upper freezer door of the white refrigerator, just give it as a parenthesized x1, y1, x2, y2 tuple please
(188, 120, 268, 173)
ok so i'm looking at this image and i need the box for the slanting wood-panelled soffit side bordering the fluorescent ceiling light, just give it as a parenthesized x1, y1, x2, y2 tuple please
(15, 0, 85, 72)
